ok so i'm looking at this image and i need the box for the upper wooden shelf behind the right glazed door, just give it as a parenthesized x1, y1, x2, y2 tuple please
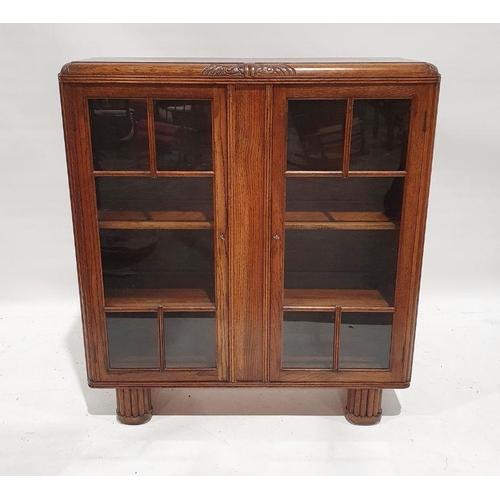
(285, 212, 396, 230)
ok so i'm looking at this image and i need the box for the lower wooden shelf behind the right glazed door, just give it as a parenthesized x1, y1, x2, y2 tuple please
(283, 289, 394, 312)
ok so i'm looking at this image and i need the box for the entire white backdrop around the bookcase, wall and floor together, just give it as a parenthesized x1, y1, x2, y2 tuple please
(0, 24, 500, 475)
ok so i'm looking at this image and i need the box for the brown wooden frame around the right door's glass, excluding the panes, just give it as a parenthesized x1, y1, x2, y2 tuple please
(269, 84, 437, 387)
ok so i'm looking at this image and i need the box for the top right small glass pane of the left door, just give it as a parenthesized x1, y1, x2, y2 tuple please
(154, 100, 212, 170)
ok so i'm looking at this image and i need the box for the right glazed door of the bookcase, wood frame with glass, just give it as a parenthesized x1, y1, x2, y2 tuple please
(270, 86, 418, 385)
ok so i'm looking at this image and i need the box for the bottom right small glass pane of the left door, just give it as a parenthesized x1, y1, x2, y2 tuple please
(163, 312, 216, 368)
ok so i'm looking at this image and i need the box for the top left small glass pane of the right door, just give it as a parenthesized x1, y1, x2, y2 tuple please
(287, 99, 347, 170)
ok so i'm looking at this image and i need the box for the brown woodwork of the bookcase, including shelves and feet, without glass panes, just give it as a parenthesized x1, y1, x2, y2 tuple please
(59, 59, 440, 424)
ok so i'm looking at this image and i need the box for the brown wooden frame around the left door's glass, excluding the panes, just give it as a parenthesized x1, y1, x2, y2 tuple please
(61, 84, 229, 387)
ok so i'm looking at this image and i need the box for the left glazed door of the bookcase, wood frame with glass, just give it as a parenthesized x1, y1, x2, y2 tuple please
(74, 86, 228, 383)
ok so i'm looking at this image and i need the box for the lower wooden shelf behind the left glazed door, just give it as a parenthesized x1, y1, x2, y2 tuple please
(104, 288, 215, 312)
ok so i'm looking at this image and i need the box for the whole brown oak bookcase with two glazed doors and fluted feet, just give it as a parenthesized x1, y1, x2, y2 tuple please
(59, 59, 440, 425)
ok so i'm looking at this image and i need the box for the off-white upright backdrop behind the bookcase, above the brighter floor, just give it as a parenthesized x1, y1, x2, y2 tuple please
(0, 24, 500, 311)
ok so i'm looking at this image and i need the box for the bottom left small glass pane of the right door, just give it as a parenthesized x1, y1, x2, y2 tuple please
(282, 312, 334, 370)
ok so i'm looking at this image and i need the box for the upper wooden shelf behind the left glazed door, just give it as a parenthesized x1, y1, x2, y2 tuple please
(98, 210, 213, 229)
